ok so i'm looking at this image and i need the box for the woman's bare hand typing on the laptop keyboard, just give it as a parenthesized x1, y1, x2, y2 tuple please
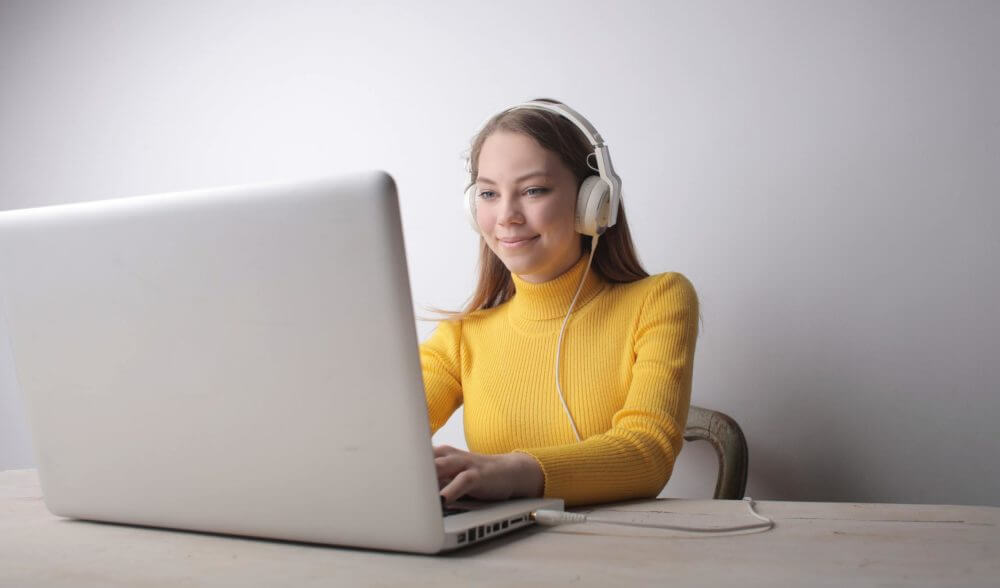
(434, 445, 545, 502)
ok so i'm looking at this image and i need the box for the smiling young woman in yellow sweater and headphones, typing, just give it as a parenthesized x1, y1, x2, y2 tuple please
(420, 99, 698, 506)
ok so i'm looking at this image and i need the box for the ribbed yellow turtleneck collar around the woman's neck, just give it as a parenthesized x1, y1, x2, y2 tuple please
(510, 254, 604, 321)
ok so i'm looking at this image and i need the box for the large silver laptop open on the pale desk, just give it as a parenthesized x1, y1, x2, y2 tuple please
(0, 171, 563, 553)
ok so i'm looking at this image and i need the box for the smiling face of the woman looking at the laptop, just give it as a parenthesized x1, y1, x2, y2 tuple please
(476, 131, 582, 283)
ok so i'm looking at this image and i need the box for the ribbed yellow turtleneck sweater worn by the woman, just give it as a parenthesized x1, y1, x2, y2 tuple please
(420, 256, 698, 505)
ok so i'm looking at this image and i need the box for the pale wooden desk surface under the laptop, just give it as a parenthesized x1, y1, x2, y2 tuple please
(0, 470, 1000, 588)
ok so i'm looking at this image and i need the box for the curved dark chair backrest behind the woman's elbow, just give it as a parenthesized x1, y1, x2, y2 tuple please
(684, 405, 749, 500)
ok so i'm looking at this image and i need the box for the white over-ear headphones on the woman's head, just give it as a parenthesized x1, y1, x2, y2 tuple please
(463, 100, 622, 237)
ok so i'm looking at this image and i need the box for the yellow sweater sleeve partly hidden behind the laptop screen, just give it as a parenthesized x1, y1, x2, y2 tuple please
(420, 321, 462, 435)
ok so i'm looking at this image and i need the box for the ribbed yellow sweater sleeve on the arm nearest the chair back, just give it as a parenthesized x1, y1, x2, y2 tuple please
(519, 273, 698, 506)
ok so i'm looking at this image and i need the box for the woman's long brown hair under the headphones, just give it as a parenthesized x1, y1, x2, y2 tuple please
(435, 98, 649, 320)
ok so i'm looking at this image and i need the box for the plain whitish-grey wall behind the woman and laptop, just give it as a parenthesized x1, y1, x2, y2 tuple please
(0, 0, 1000, 504)
